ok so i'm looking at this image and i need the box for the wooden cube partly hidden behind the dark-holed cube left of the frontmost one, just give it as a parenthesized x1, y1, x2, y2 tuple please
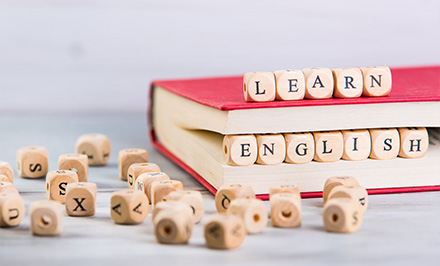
(165, 190, 205, 224)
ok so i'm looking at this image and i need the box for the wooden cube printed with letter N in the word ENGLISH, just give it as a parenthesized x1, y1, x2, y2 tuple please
(257, 134, 286, 165)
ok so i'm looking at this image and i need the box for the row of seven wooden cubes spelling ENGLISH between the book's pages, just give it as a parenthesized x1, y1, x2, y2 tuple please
(223, 128, 429, 166)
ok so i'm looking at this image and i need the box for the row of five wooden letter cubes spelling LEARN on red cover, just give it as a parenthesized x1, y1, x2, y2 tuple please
(243, 66, 392, 102)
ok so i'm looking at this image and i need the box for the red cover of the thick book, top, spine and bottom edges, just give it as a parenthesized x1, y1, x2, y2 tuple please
(147, 66, 440, 199)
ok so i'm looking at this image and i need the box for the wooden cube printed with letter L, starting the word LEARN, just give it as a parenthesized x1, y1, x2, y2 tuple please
(243, 72, 275, 102)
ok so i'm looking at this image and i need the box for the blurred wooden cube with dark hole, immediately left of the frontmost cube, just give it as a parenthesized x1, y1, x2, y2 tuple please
(154, 210, 194, 244)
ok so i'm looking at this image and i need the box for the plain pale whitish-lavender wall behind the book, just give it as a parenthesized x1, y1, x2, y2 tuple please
(0, 0, 440, 115)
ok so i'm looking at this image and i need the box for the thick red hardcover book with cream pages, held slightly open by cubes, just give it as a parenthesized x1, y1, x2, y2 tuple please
(148, 66, 440, 199)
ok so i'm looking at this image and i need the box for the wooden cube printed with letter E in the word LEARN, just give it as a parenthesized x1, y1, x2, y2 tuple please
(274, 69, 306, 101)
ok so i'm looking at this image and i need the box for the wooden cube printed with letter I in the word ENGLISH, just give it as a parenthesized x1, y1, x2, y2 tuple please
(341, 129, 371, 161)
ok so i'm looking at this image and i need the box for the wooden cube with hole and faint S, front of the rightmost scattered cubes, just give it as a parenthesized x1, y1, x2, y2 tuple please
(322, 198, 362, 233)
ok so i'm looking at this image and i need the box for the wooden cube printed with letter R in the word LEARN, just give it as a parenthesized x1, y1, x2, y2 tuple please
(332, 68, 364, 98)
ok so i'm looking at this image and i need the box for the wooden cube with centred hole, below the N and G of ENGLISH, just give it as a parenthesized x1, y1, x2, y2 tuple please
(270, 193, 301, 227)
